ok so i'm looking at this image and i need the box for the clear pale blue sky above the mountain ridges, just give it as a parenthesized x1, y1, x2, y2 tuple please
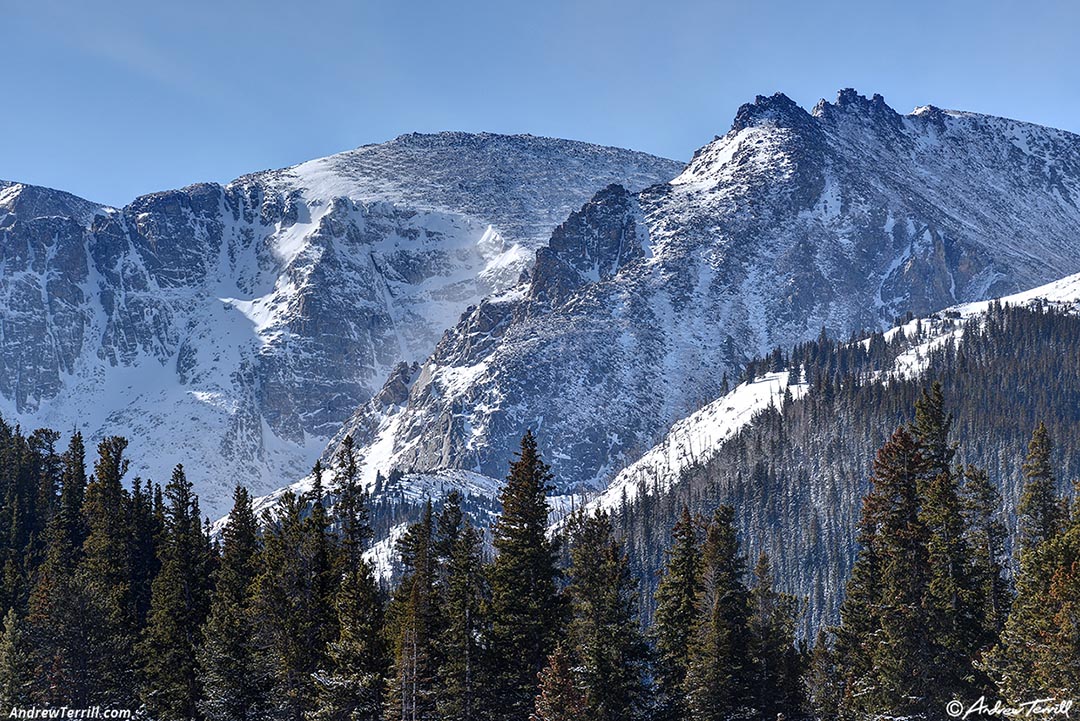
(0, 0, 1080, 204)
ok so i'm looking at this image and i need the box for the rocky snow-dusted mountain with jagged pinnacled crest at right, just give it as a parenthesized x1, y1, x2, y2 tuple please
(330, 90, 1080, 507)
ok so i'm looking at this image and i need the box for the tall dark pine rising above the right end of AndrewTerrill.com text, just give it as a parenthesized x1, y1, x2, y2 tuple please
(77, 436, 138, 708)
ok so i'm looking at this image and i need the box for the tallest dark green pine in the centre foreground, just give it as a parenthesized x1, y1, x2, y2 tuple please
(490, 432, 563, 721)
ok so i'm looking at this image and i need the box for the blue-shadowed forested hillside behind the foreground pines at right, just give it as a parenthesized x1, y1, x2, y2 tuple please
(615, 303, 1080, 634)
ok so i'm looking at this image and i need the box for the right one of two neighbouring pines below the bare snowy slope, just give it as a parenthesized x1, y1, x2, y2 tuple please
(685, 505, 748, 720)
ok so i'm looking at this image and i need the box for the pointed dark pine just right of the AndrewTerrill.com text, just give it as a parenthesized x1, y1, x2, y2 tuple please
(139, 465, 210, 721)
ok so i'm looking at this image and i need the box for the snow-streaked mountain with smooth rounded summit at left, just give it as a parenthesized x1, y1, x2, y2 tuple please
(0, 133, 683, 514)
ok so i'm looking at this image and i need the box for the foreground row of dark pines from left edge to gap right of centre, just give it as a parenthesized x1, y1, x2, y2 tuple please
(0, 425, 806, 721)
